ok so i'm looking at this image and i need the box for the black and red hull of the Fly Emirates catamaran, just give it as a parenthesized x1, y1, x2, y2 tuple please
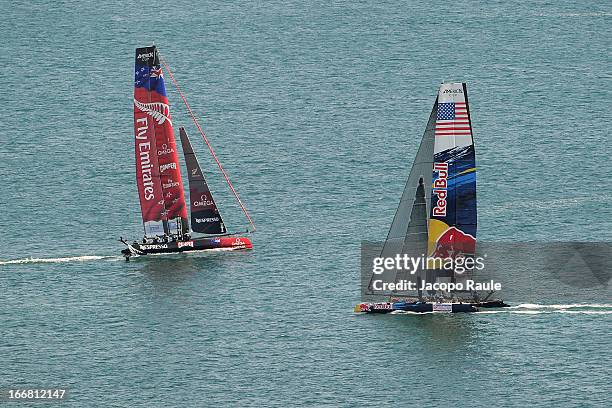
(121, 237, 253, 258)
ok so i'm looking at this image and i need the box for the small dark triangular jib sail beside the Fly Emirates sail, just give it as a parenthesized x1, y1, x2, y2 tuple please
(179, 128, 226, 234)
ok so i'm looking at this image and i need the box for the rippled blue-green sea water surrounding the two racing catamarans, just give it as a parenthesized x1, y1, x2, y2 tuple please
(0, 0, 612, 407)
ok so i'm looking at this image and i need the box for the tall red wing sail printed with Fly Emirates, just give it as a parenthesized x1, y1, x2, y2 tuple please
(134, 46, 187, 233)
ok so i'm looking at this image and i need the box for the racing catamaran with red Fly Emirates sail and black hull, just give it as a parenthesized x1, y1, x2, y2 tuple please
(120, 46, 255, 260)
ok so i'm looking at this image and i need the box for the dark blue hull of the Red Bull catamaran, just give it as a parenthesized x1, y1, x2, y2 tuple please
(355, 300, 509, 314)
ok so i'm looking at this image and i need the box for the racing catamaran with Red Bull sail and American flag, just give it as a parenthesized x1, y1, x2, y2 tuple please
(355, 82, 507, 313)
